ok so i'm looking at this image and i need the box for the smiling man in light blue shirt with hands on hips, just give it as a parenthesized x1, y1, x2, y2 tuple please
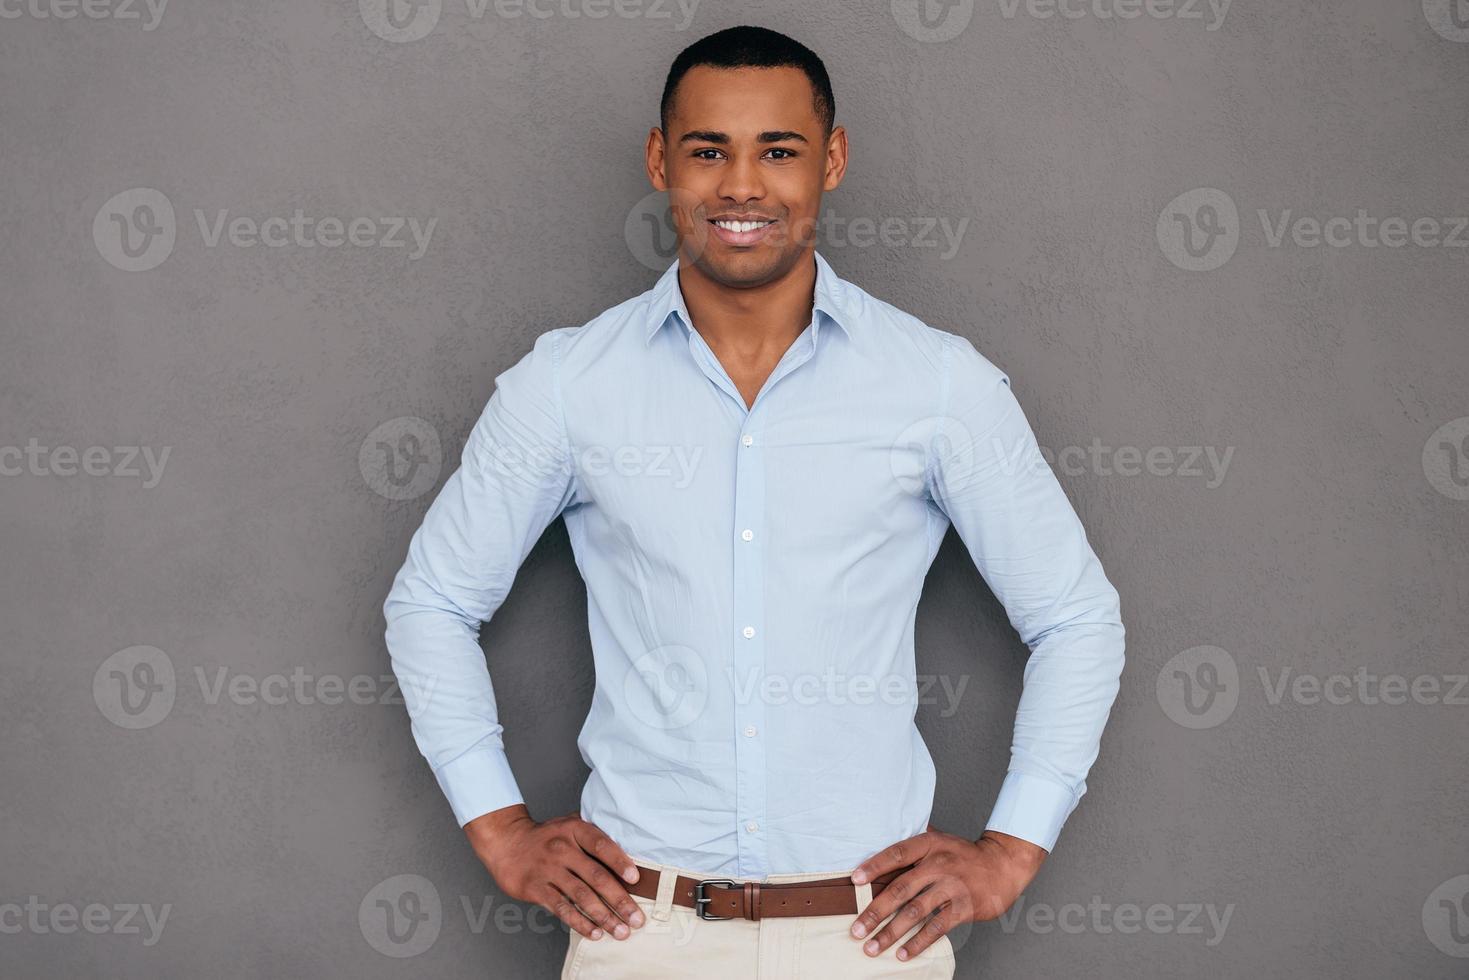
(383, 26, 1124, 979)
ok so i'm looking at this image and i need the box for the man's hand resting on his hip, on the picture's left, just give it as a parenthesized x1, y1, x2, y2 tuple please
(464, 804, 643, 939)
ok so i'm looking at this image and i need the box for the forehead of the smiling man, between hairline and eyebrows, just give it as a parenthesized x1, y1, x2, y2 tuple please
(668, 65, 821, 138)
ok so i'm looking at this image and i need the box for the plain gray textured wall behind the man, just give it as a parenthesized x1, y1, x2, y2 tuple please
(0, 0, 1469, 977)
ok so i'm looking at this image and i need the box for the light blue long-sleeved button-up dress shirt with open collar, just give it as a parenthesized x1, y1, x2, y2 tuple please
(383, 253, 1124, 877)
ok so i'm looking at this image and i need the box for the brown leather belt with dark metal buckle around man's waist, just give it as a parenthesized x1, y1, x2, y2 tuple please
(624, 864, 914, 923)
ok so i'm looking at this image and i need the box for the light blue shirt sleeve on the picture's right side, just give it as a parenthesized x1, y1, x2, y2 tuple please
(925, 335, 1124, 851)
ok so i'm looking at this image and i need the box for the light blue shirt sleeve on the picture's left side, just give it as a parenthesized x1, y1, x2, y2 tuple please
(382, 331, 573, 826)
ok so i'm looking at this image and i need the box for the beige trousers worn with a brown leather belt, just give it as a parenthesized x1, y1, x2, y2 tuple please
(561, 854, 953, 980)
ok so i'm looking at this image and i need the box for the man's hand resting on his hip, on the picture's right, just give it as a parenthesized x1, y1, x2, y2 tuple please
(852, 824, 1047, 959)
